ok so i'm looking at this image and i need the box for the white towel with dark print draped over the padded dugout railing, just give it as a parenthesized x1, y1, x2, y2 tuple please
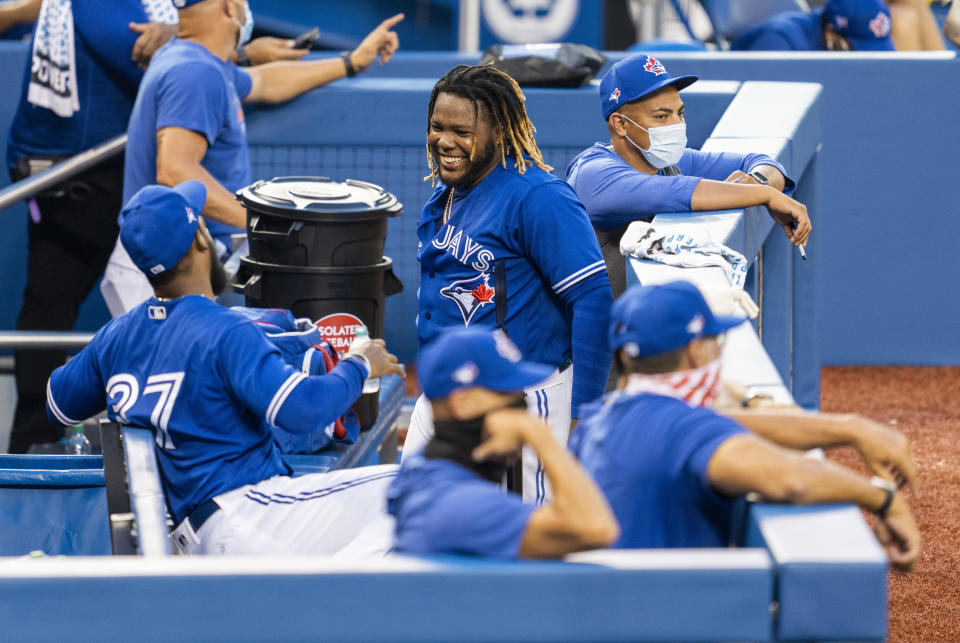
(620, 221, 759, 319)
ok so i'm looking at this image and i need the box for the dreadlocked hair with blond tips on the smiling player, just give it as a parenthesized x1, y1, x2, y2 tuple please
(423, 63, 553, 185)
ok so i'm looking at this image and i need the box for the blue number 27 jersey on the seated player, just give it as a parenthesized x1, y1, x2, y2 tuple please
(47, 295, 367, 522)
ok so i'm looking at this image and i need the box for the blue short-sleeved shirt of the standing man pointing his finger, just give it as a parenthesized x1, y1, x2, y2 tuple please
(123, 38, 252, 242)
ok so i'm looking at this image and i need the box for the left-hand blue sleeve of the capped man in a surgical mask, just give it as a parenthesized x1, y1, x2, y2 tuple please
(570, 154, 700, 229)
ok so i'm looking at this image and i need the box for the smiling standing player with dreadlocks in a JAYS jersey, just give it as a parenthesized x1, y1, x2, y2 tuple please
(404, 65, 612, 502)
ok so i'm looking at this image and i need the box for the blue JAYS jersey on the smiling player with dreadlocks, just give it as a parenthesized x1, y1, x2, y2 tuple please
(417, 162, 606, 366)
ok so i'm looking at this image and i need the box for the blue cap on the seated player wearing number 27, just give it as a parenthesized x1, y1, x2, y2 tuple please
(120, 181, 207, 277)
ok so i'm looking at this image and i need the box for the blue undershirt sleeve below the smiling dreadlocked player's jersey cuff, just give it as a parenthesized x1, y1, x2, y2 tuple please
(565, 272, 613, 418)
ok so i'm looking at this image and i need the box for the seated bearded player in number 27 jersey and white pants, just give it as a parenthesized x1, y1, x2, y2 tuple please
(47, 181, 401, 554)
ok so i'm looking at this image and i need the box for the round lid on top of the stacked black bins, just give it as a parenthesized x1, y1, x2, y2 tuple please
(237, 176, 403, 218)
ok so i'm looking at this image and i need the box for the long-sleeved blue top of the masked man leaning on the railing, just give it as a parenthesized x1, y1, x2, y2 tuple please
(567, 143, 797, 229)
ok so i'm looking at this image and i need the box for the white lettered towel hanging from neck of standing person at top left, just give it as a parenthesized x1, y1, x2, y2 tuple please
(27, 0, 178, 118)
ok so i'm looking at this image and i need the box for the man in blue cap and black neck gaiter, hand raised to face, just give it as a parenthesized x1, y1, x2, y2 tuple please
(387, 328, 618, 559)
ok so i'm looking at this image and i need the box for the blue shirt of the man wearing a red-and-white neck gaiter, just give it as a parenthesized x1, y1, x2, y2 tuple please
(569, 393, 746, 548)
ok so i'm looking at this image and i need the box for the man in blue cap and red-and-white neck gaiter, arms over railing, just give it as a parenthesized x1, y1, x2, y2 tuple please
(570, 281, 920, 569)
